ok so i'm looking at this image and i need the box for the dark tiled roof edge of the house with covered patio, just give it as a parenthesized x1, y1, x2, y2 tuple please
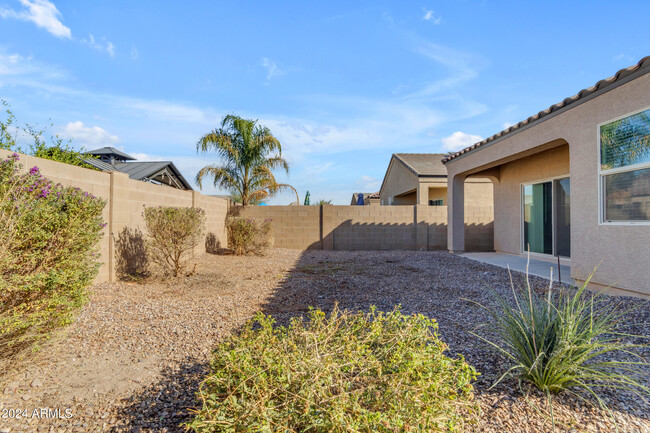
(442, 56, 650, 164)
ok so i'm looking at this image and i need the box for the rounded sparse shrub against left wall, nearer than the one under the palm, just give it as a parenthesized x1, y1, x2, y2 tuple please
(143, 206, 205, 277)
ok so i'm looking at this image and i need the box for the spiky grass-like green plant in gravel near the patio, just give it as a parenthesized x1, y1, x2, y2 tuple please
(475, 278, 649, 411)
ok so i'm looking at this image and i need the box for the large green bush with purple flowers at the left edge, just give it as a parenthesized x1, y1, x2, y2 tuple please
(0, 153, 105, 361)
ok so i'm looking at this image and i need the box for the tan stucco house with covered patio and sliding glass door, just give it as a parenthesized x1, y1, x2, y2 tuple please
(443, 57, 650, 295)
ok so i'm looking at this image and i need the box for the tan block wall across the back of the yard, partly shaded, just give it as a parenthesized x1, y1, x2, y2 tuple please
(240, 205, 494, 251)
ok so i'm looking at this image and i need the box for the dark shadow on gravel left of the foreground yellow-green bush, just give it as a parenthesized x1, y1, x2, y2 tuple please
(109, 360, 209, 433)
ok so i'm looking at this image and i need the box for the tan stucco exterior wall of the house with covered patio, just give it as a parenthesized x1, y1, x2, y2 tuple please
(447, 74, 650, 295)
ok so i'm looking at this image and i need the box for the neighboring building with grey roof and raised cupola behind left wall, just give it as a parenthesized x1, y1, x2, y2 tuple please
(84, 147, 192, 190)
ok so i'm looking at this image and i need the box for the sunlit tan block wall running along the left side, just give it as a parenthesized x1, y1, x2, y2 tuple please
(0, 150, 229, 282)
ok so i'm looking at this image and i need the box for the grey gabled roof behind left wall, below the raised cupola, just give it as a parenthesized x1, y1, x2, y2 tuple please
(84, 158, 192, 190)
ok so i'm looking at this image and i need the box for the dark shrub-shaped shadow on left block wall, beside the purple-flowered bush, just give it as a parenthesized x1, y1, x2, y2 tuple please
(115, 227, 149, 281)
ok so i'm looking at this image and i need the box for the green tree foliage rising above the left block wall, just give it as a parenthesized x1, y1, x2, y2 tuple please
(0, 100, 98, 170)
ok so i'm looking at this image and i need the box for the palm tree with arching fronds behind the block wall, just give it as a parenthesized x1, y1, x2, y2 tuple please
(196, 114, 295, 206)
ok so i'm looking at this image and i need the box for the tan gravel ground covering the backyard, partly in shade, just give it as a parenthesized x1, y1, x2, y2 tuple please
(0, 249, 650, 433)
